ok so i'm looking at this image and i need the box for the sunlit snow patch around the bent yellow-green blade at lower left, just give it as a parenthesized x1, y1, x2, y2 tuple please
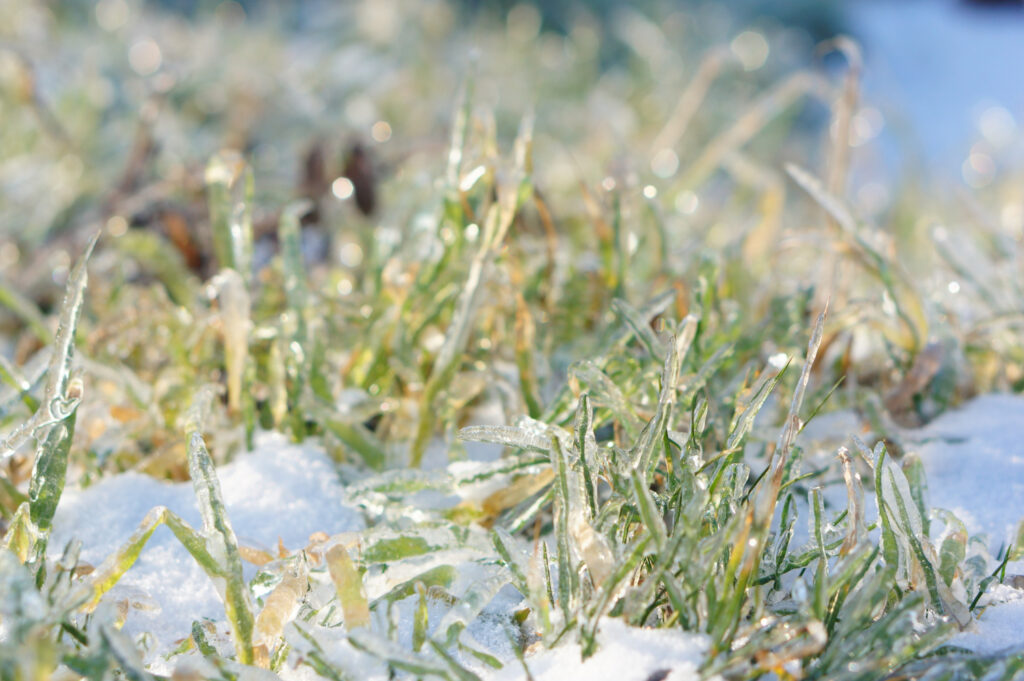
(50, 433, 365, 673)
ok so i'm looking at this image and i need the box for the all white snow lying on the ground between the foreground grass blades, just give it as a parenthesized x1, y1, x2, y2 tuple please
(51, 395, 1024, 681)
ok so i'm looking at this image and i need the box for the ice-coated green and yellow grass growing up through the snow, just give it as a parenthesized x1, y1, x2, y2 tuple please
(0, 1, 1024, 680)
